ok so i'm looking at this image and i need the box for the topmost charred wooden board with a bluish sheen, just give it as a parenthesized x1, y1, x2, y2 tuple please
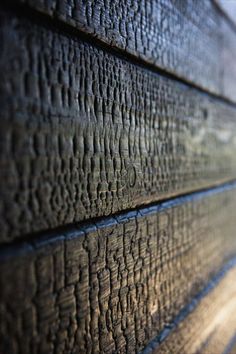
(8, 0, 236, 101)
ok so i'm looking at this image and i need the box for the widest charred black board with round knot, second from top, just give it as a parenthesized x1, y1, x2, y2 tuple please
(0, 12, 236, 242)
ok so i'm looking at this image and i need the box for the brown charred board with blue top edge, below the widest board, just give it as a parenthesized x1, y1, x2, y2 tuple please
(0, 184, 236, 354)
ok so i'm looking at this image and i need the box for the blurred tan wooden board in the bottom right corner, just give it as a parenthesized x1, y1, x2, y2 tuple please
(148, 266, 236, 354)
